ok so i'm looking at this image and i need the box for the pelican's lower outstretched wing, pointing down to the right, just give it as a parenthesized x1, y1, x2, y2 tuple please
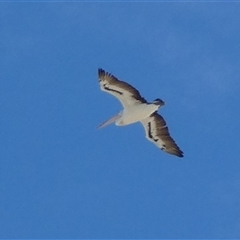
(141, 112, 183, 157)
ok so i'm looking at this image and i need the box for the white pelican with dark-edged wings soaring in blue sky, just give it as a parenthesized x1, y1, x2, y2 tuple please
(98, 68, 183, 157)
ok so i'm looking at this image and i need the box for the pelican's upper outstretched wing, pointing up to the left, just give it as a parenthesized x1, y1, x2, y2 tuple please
(98, 68, 147, 108)
